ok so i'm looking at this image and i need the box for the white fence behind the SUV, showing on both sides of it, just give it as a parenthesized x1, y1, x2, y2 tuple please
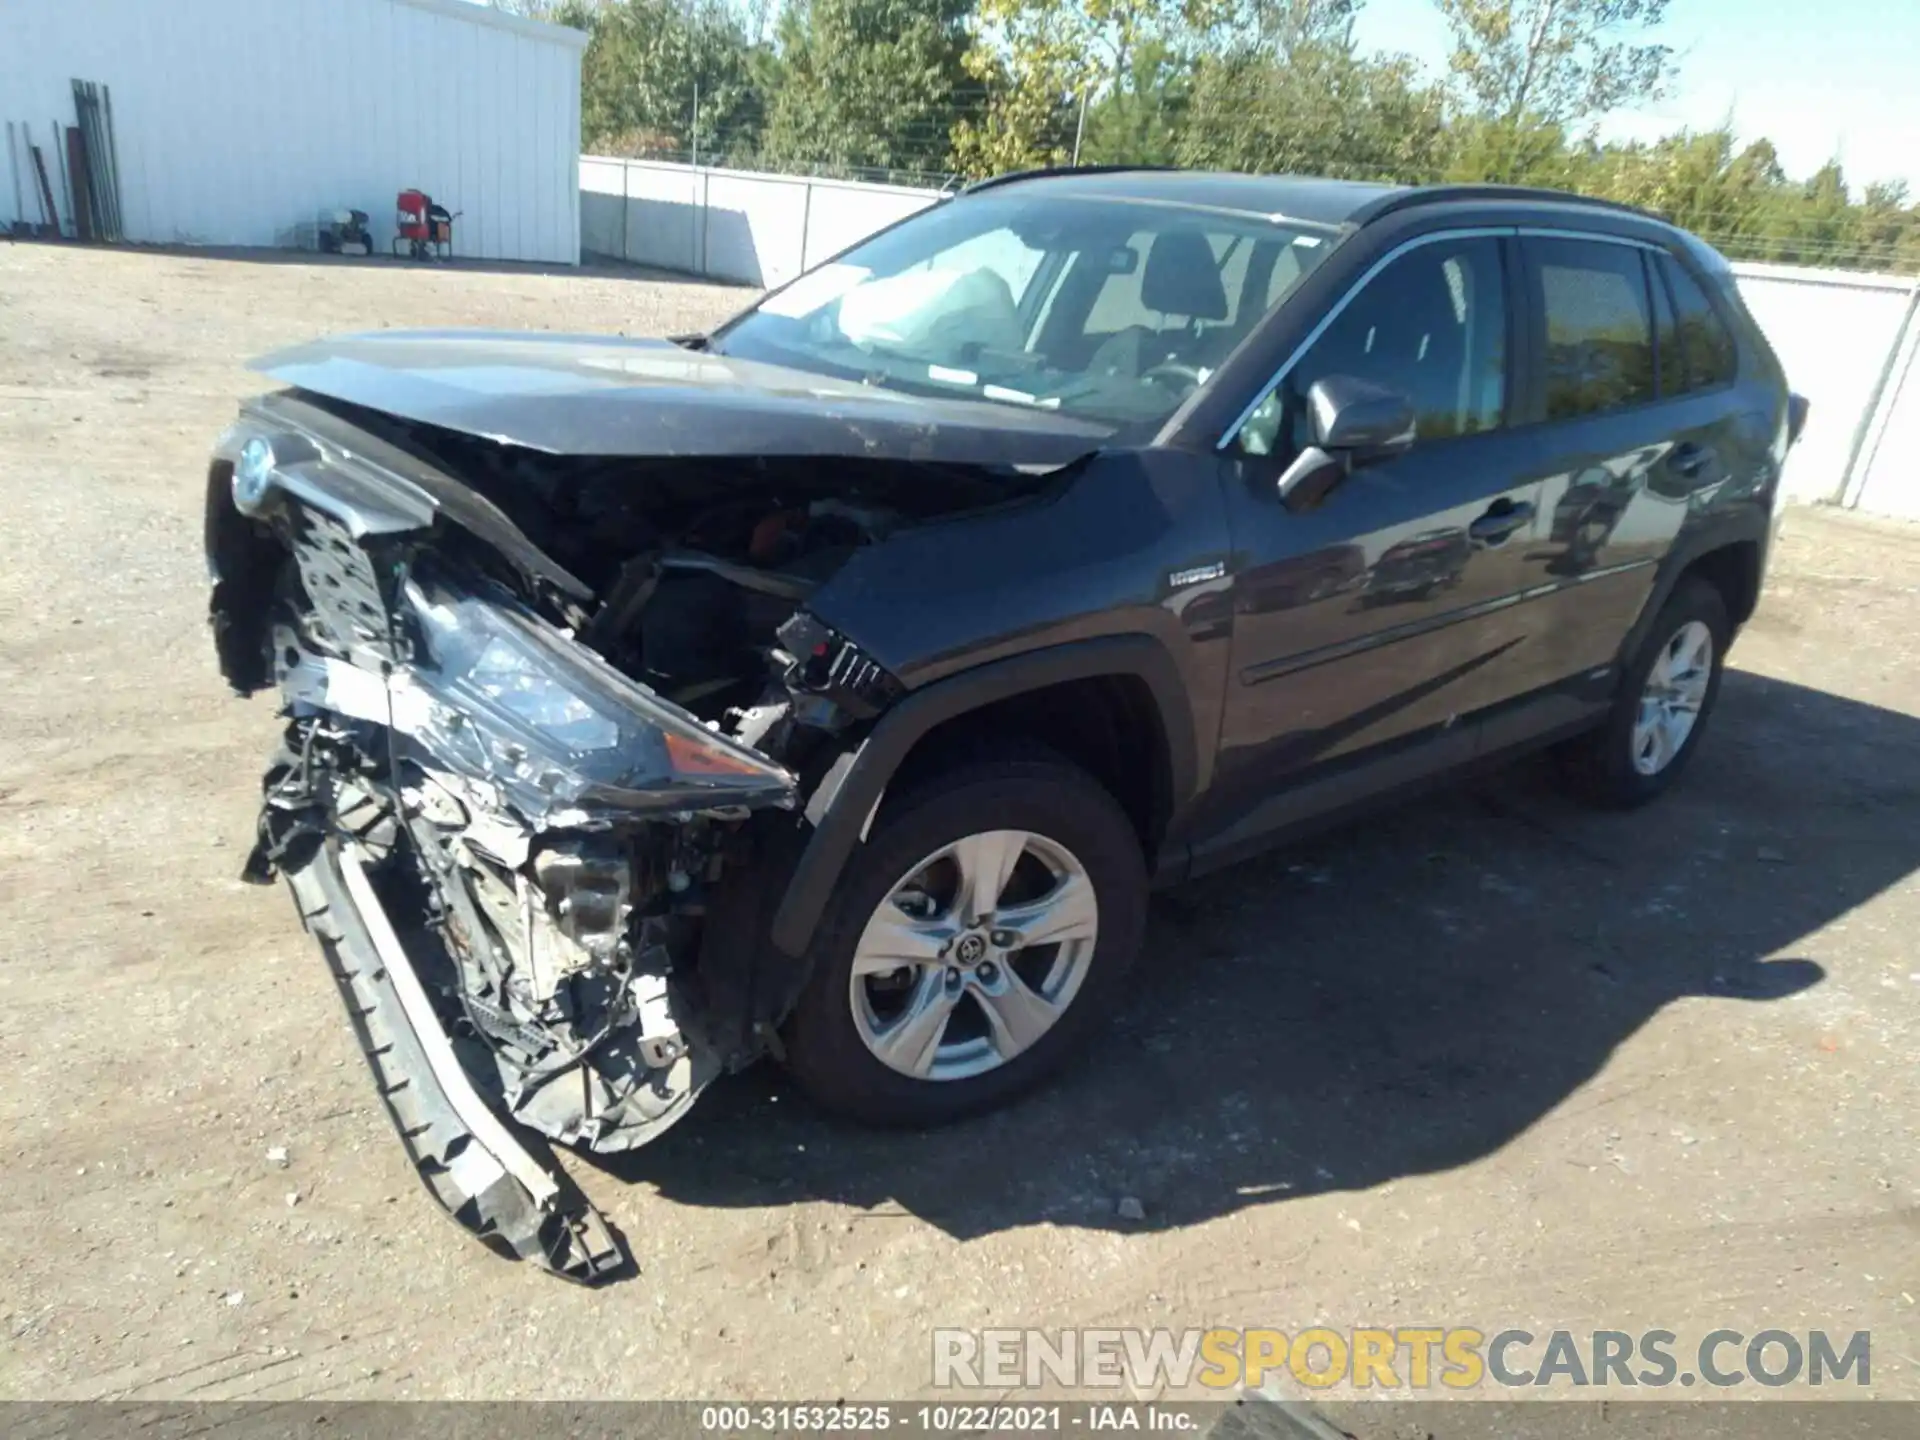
(580, 156, 1920, 520)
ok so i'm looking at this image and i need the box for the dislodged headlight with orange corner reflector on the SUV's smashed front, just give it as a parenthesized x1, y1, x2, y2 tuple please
(392, 582, 793, 824)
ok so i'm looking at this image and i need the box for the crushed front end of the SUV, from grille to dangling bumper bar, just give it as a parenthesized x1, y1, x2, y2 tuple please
(207, 396, 864, 1281)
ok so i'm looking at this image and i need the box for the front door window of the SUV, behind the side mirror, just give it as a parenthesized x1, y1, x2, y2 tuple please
(1238, 236, 1507, 455)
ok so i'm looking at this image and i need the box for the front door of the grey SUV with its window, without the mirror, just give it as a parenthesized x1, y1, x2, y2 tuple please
(1200, 230, 1546, 851)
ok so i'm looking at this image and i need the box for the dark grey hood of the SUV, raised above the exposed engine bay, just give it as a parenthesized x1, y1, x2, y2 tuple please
(252, 330, 1112, 468)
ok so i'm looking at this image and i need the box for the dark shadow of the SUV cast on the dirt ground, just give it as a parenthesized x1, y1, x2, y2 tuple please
(589, 672, 1920, 1238)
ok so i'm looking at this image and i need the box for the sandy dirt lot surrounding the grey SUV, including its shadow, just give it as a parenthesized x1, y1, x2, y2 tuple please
(0, 246, 1920, 1398)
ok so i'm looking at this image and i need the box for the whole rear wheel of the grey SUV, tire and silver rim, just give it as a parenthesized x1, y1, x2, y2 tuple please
(1559, 578, 1732, 806)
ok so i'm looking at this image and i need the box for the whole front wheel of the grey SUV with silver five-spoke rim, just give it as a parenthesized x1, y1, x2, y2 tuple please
(785, 753, 1146, 1125)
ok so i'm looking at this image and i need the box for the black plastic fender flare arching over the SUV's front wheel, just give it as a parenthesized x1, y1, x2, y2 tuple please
(772, 634, 1198, 958)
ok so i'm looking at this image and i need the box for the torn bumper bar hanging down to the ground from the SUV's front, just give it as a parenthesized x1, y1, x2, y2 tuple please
(286, 843, 630, 1284)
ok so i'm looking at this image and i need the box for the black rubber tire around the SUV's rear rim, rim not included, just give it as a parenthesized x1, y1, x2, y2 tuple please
(1555, 578, 1734, 810)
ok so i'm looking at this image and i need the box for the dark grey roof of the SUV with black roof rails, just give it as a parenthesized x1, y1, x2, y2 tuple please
(962, 165, 1661, 227)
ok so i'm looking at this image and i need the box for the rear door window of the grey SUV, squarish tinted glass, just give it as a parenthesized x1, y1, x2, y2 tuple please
(1526, 240, 1655, 420)
